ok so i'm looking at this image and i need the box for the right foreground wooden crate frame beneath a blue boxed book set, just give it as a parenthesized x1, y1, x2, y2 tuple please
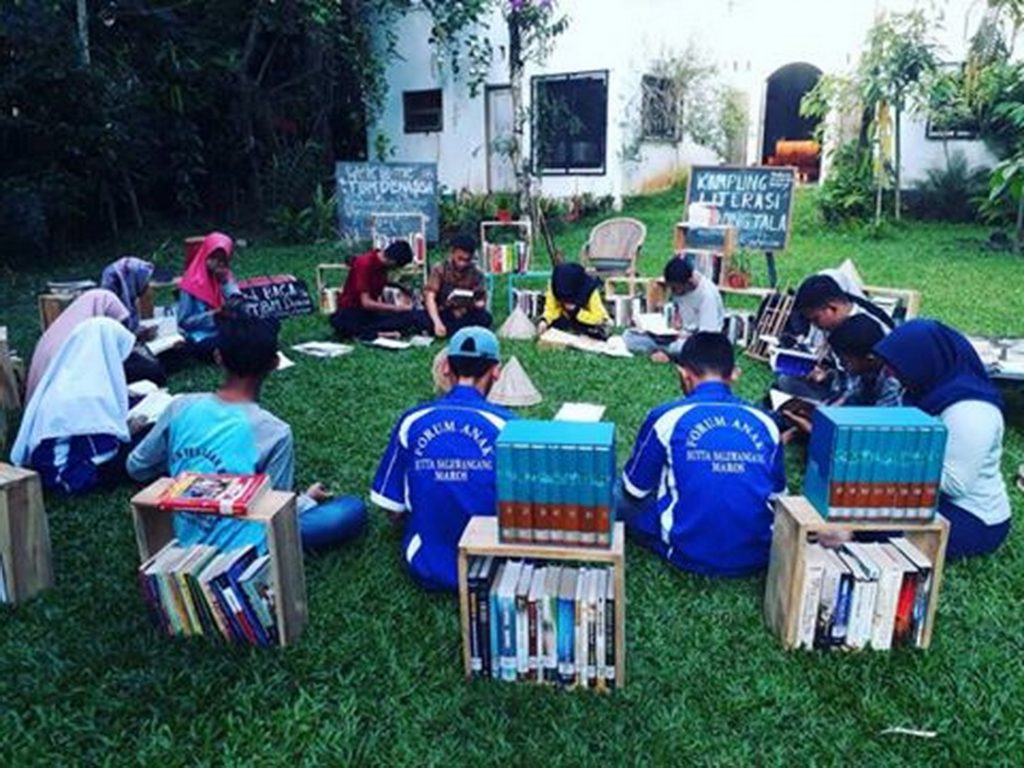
(764, 496, 949, 649)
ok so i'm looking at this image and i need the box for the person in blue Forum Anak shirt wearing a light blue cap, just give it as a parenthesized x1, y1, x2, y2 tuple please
(370, 327, 515, 591)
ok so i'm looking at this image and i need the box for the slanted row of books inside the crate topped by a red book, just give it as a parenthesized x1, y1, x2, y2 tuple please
(138, 539, 280, 646)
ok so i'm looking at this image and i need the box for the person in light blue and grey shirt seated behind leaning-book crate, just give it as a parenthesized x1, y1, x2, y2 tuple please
(127, 316, 367, 550)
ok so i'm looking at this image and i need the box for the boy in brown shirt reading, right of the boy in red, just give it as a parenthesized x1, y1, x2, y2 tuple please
(424, 234, 494, 338)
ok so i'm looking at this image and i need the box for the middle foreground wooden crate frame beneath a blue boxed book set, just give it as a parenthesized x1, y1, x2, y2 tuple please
(459, 517, 626, 688)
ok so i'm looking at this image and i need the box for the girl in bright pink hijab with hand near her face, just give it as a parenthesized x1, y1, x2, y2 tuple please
(177, 232, 239, 359)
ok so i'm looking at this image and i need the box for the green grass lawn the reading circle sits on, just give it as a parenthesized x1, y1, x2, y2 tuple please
(0, 194, 1024, 766)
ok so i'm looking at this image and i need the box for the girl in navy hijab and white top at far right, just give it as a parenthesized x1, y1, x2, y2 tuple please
(874, 319, 1010, 558)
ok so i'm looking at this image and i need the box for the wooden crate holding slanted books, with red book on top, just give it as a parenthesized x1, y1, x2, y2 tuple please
(131, 477, 308, 645)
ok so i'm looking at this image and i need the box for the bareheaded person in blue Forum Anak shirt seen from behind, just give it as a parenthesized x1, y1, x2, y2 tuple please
(618, 333, 785, 577)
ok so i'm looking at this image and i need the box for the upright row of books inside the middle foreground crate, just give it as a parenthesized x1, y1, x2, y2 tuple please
(468, 557, 616, 690)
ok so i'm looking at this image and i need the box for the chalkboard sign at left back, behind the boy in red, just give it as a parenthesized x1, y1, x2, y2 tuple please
(335, 163, 437, 243)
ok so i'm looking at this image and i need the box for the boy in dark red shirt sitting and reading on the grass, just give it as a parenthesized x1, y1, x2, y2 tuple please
(331, 240, 424, 340)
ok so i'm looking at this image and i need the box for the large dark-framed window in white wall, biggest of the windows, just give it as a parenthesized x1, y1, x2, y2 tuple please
(530, 71, 608, 176)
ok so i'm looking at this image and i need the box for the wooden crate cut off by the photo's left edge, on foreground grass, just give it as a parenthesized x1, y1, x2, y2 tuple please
(0, 463, 53, 603)
